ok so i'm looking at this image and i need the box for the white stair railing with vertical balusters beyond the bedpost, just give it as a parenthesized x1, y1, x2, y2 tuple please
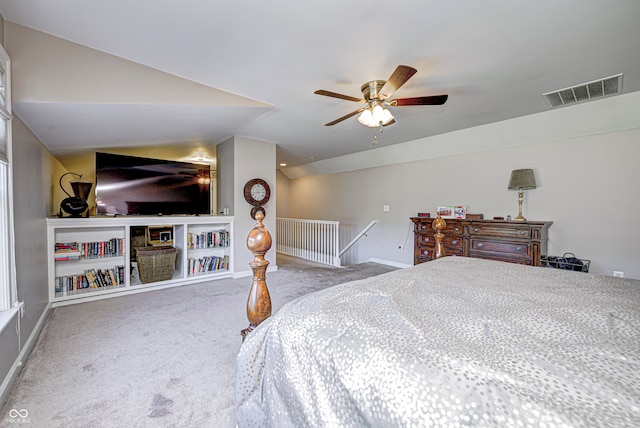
(276, 218, 340, 267)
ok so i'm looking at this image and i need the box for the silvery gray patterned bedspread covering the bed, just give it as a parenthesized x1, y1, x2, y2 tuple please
(236, 257, 640, 428)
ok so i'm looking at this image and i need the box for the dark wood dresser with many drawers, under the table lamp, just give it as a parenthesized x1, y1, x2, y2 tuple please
(411, 217, 553, 266)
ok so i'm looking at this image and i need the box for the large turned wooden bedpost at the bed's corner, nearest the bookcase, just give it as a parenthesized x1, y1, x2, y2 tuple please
(241, 211, 271, 341)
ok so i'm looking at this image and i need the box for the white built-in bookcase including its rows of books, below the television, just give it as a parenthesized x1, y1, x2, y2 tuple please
(47, 216, 233, 306)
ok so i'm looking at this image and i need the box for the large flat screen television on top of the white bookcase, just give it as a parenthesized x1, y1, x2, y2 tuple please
(96, 152, 211, 215)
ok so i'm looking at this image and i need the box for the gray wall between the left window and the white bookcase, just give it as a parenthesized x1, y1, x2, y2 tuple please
(0, 116, 53, 402)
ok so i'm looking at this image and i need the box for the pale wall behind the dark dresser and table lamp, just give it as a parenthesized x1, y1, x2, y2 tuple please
(289, 123, 640, 279)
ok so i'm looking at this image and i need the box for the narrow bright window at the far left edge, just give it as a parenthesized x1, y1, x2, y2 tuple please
(0, 42, 18, 311)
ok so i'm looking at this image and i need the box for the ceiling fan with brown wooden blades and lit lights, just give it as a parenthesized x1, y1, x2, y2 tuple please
(314, 65, 449, 127)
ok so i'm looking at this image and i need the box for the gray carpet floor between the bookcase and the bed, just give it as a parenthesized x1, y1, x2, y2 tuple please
(0, 255, 395, 428)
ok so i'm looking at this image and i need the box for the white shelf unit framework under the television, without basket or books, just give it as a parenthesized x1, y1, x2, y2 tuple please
(47, 216, 234, 307)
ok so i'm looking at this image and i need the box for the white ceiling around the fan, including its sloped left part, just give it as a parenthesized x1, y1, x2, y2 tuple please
(0, 0, 640, 166)
